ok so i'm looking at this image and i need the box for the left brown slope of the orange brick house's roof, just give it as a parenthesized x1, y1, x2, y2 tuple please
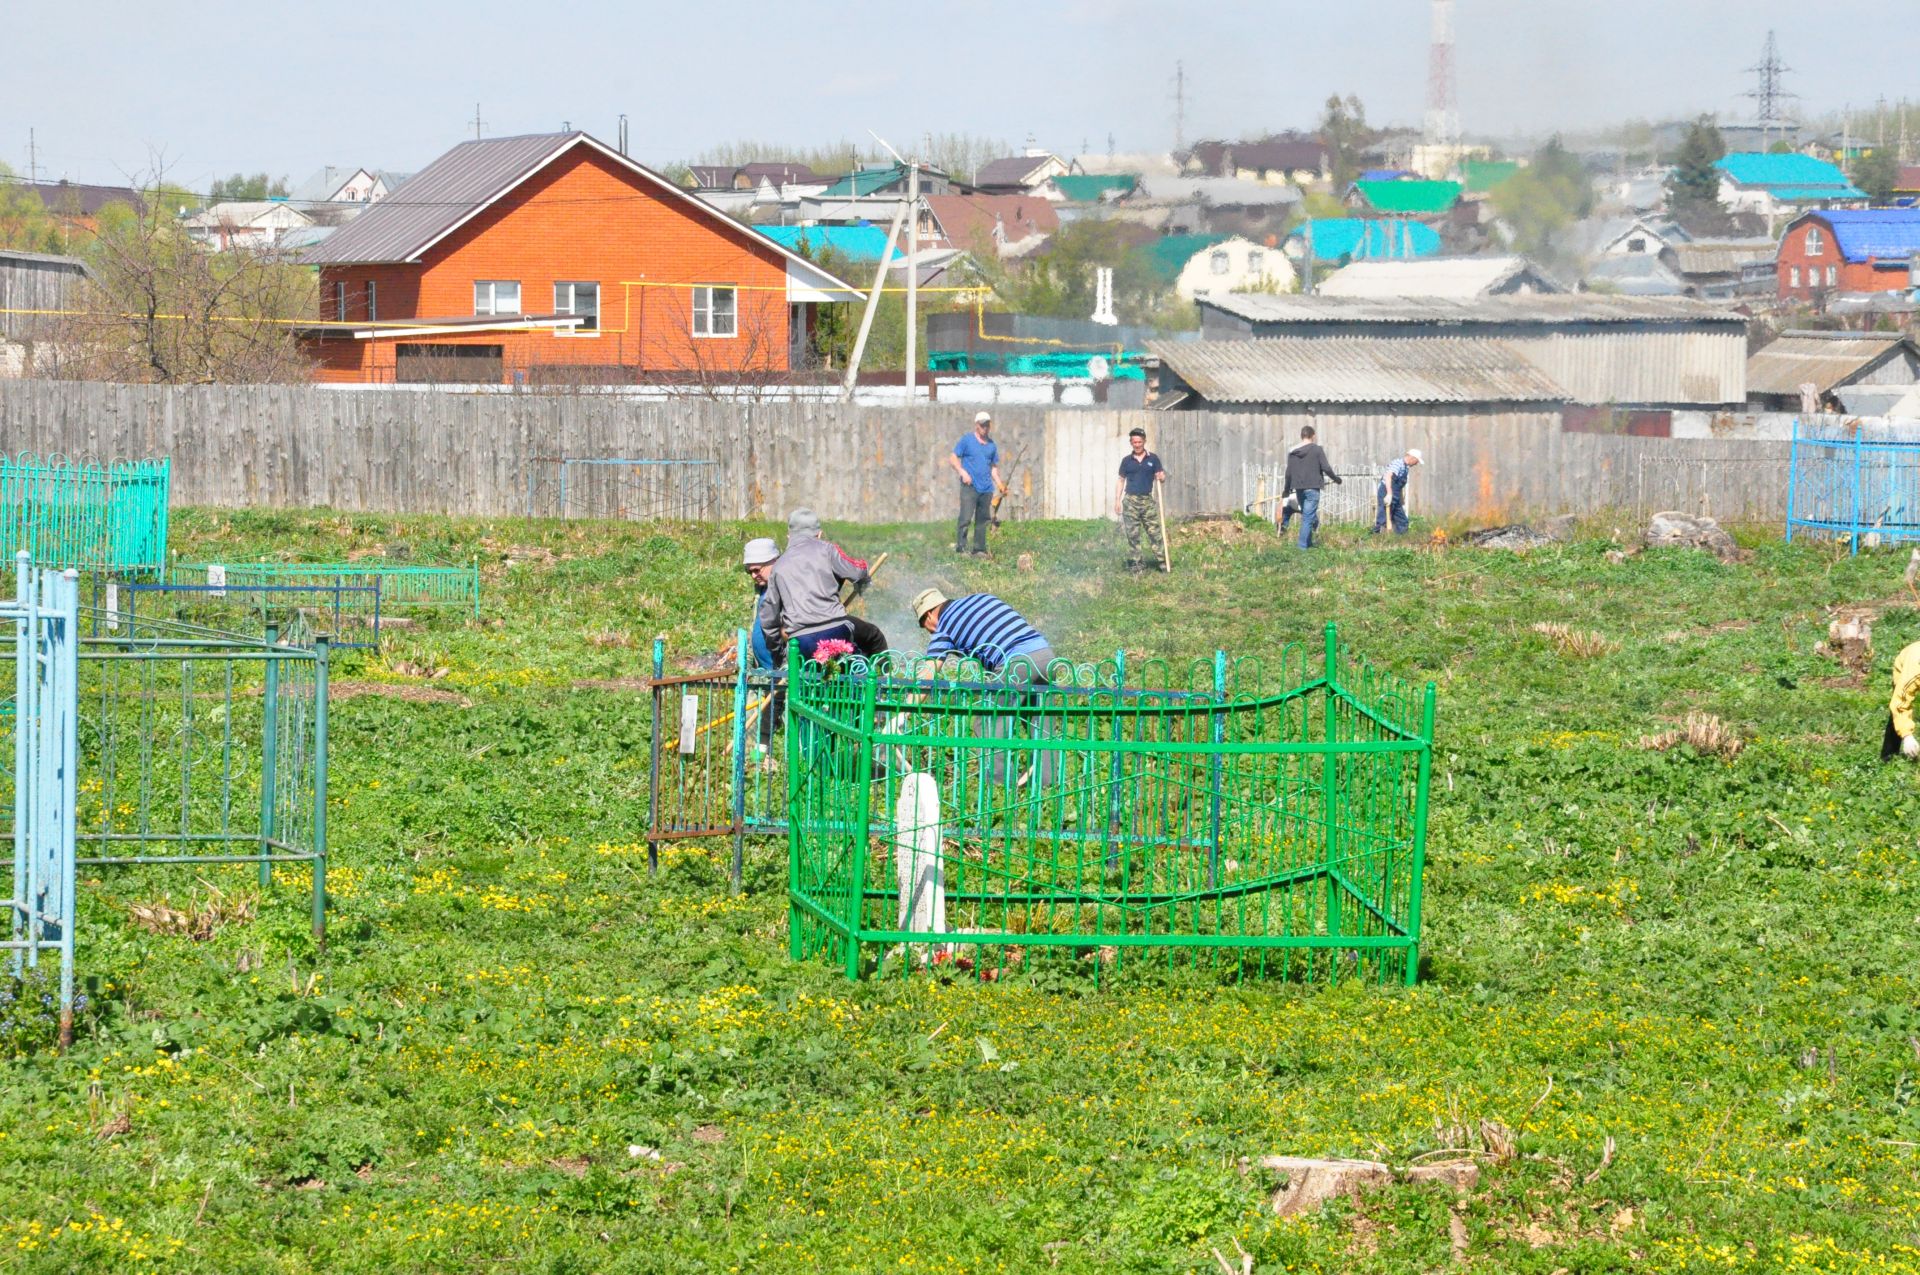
(301, 132, 586, 265)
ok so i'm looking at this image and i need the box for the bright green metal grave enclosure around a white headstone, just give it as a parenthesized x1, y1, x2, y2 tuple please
(787, 626, 1434, 983)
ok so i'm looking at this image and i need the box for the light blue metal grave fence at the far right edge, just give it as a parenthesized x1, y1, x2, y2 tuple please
(1788, 417, 1920, 553)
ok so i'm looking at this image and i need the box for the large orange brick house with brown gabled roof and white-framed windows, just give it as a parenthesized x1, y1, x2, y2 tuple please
(301, 132, 856, 384)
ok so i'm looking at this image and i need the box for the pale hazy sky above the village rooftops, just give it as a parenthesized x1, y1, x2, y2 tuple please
(0, 0, 1920, 188)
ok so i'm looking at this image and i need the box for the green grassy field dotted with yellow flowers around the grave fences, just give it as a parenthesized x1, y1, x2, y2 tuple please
(0, 511, 1920, 1275)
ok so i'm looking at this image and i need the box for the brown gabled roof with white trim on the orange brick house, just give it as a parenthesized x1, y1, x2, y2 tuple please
(301, 132, 852, 294)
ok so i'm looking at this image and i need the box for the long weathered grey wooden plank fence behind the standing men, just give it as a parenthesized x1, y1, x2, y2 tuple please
(0, 380, 1788, 522)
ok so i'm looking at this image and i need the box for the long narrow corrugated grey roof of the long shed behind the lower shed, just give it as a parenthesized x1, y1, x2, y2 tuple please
(1200, 292, 1747, 325)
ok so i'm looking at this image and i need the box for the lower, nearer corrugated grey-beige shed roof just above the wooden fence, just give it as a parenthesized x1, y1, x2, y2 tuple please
(1148, 336, 1567, 403)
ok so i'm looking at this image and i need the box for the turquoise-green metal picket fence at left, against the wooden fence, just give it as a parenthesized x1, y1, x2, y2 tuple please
(0, 453, 171, 576)
